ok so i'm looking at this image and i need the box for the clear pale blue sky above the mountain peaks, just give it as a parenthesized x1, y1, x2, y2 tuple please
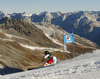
(0, 0, 100, 13)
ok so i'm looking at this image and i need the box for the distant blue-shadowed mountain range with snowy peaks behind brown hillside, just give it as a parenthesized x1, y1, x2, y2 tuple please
(0, 11, 100, 45)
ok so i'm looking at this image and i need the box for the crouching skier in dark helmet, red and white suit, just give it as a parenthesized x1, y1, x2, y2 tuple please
(42, 51, 57, 66)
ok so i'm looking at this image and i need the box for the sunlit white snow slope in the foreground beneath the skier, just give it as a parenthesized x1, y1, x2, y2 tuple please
(0, 50, 100, 79)
